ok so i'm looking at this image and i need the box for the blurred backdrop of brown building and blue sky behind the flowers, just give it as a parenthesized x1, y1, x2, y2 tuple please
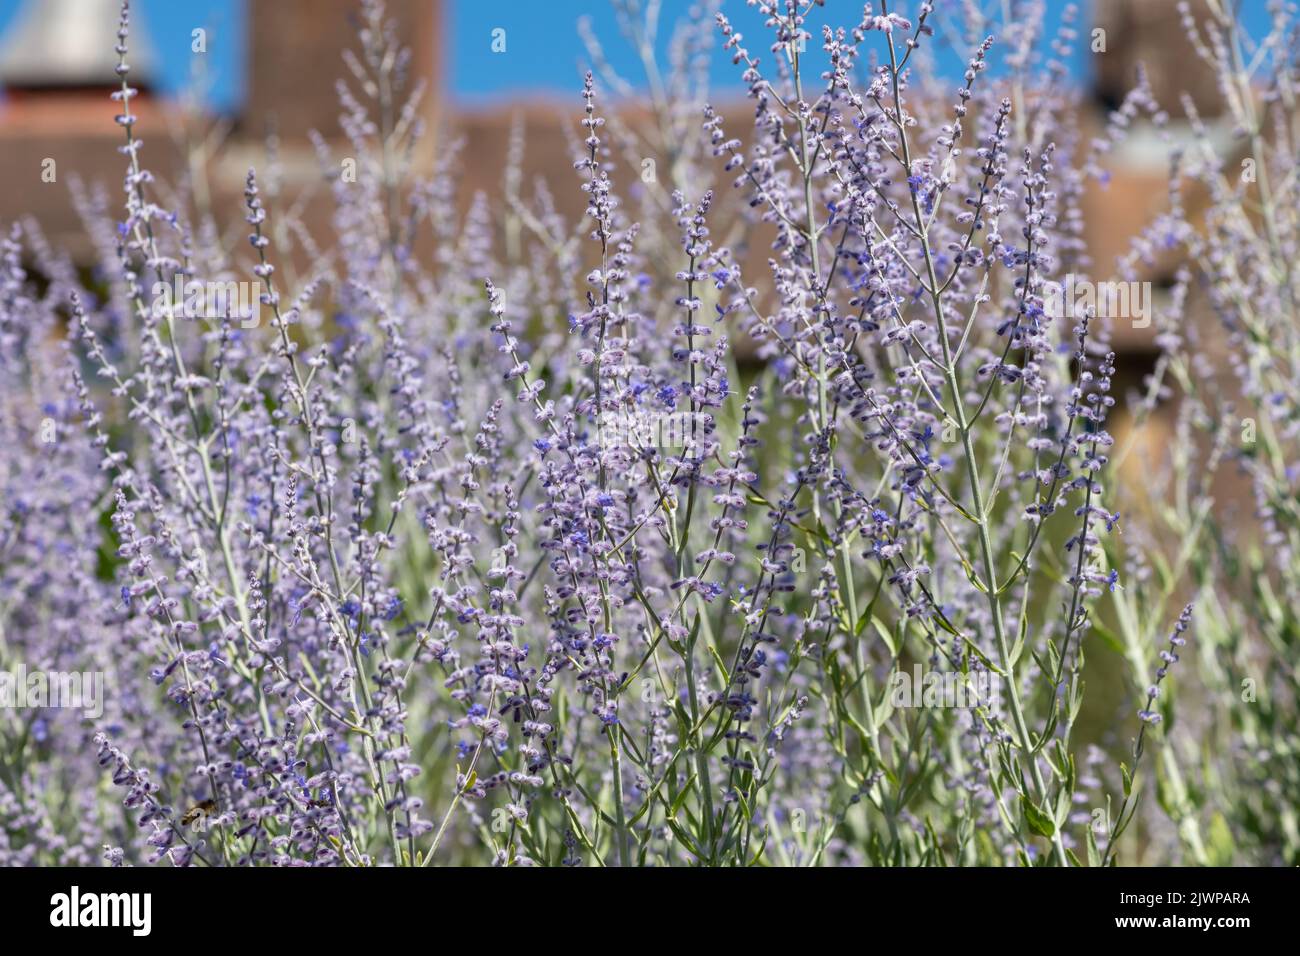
(0, 0, 1266, 494)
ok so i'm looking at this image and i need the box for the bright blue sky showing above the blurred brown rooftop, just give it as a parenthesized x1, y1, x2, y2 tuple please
(0, 0, 1265, 111)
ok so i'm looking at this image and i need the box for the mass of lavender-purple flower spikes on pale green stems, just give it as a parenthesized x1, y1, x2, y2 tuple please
(0, 0, 1296, 866)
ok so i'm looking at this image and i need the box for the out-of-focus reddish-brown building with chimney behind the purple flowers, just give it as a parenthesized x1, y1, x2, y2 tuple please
(0, 0, 1221, 350)
